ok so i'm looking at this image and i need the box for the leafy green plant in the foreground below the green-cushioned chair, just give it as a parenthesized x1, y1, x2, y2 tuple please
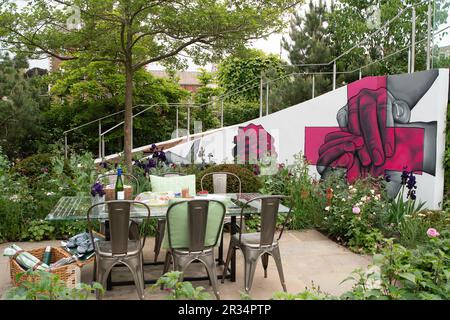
(151, 271, 211, 300)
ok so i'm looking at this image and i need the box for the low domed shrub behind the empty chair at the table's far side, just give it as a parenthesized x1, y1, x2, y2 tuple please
(197, 164, 262, 193)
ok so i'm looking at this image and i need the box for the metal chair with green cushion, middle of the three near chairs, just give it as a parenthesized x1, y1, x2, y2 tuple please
(163, 200, 226, 300)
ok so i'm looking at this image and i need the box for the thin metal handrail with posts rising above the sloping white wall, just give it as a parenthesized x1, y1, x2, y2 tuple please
(63, 0, 442, 158)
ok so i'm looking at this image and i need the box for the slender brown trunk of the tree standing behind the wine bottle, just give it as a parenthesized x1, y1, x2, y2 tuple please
(124, 58, 133, 174)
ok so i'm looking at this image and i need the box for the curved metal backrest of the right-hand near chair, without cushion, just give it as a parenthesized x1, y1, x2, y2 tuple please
(239, 195, 292, 246)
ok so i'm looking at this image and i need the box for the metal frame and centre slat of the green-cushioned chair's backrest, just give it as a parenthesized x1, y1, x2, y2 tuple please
(166, 200, 226, 251)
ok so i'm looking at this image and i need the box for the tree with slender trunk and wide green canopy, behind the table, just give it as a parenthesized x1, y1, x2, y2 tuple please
(0, 0, 300, 171)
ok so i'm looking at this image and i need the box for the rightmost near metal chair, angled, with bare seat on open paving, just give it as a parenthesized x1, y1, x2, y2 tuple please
(222, 195, 292, 293)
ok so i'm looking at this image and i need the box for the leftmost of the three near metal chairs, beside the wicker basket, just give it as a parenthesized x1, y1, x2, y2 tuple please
(87, 200, 150, 299)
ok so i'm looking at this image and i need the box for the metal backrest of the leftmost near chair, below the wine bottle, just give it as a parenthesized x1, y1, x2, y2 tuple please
(87, 200, 150, 255)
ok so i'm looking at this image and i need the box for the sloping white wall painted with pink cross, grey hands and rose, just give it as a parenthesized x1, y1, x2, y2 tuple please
(167, 69, 449, 209)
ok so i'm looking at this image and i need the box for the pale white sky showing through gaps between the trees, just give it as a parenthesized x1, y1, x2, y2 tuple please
(27, 0, 450, 70)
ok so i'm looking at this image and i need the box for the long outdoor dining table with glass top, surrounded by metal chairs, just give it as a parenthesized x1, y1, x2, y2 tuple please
(45, 193, 289, 289)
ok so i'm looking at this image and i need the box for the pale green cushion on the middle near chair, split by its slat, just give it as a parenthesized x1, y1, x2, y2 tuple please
(162, 199, 225, 249)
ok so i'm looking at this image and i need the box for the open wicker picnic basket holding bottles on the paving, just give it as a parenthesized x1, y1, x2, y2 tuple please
(9, 247, 80, 288)
